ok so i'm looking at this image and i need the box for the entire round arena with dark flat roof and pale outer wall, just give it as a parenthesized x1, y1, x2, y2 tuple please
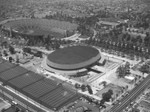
(46, 46, 101, 71)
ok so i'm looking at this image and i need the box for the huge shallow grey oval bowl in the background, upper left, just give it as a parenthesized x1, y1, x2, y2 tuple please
(3, 19, 78, 38)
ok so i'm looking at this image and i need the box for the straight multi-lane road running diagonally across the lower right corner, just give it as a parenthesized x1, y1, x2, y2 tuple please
(108, 75, 150, 112)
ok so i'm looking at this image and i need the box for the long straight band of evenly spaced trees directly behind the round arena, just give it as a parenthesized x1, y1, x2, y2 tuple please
(83, 35, 150, 58)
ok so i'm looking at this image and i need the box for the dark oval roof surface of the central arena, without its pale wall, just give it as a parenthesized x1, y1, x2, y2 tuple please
(48, 46, 99, 64)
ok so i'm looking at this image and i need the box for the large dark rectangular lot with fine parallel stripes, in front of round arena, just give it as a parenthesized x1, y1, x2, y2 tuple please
(0, 62, 80, 110)
